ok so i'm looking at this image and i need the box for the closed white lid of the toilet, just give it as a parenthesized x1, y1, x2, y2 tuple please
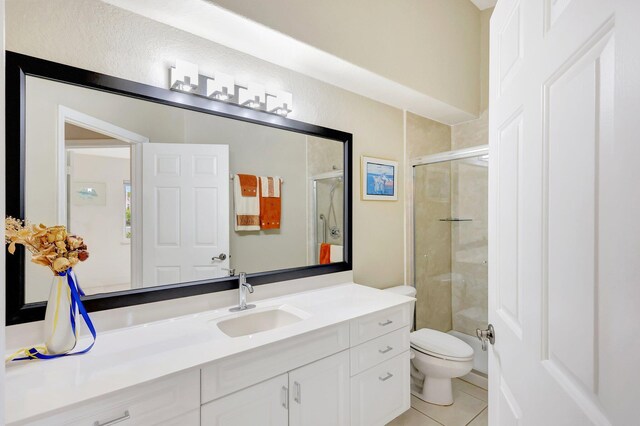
(411, 328, 473, 361)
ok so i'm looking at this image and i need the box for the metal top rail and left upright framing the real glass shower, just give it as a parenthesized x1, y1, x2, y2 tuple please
(405, 145, 491, 288)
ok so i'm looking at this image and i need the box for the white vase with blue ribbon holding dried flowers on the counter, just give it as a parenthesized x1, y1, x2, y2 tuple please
(44, 275, 80, 354)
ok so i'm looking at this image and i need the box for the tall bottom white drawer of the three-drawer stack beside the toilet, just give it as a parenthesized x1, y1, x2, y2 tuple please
(351, 351, 411, 426)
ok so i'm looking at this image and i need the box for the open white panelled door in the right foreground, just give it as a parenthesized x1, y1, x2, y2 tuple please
(489, 0, 640, 426)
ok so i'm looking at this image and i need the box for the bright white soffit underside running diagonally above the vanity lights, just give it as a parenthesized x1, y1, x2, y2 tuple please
(102, 0, 476, 125)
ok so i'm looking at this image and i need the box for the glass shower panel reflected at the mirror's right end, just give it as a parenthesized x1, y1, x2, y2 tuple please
(313, 171, 344, 264)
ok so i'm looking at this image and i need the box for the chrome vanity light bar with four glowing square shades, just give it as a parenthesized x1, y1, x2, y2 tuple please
(169, 60, 293, 117)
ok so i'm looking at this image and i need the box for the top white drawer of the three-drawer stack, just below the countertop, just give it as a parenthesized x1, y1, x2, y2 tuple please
(351, 303, 411, 347)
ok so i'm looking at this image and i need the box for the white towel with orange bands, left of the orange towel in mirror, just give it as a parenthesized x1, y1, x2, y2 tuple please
(233, 175, 260, 231)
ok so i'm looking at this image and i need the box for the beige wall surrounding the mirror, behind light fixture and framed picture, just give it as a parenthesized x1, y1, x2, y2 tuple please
(6, 0, 404, 287)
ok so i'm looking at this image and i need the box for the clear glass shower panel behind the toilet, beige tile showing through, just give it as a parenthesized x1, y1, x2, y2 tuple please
(414, 151, 489, 364)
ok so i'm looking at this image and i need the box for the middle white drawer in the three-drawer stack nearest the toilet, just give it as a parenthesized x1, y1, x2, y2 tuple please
(350, 327, 409, 376)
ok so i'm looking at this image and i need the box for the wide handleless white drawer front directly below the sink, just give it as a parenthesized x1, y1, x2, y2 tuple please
(202, 322, 349, 404)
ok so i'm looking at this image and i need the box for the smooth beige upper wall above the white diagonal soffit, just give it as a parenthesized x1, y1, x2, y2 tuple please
(213, 0, 480, 114)
